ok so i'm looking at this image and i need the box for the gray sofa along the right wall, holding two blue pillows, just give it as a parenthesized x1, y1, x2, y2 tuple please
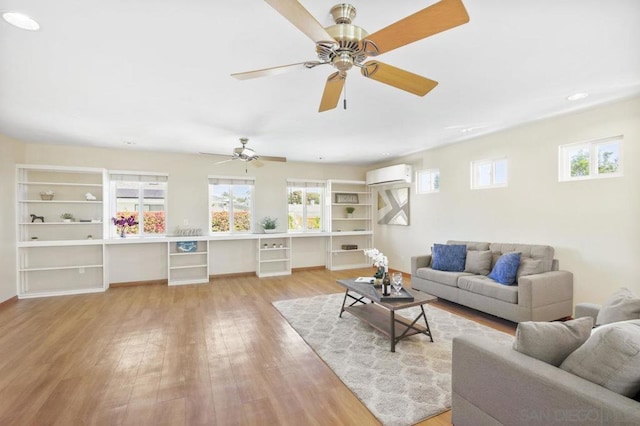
(411, 241, 573, 322)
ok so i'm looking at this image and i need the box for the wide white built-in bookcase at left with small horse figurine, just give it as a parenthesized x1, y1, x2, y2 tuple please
(16, 165, 107, 298)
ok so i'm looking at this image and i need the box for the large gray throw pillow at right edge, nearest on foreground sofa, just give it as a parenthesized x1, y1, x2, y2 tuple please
(560, 320, 640, 398)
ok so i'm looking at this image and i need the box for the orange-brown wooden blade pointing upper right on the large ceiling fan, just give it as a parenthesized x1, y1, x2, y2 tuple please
(367, 0, 469, 53)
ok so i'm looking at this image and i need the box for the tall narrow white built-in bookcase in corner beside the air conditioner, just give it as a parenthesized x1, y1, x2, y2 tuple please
(326, 180, 373, 271)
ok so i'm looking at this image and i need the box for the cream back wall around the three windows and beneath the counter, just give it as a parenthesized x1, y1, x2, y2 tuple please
(18, 143, 366, 282)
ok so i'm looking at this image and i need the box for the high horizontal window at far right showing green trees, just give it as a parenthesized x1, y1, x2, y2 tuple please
(558, 136, 622, 182)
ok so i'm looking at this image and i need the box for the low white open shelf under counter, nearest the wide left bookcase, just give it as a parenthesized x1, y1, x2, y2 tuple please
(168, 240, 209, 285)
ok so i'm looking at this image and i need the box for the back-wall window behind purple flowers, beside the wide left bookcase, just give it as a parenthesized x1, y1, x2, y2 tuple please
(109, 171, 168, 237)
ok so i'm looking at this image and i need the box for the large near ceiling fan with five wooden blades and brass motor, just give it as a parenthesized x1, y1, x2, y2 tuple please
(231, 0, 469, 112)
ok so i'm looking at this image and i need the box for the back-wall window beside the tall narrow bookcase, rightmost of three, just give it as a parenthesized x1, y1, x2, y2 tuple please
(287, 180, 325, 232)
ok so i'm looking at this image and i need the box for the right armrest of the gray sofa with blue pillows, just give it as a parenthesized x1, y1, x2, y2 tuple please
(518, 271, 573, 308)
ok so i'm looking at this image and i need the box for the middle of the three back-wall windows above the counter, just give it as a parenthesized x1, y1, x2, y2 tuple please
(209, 176, 255, 234)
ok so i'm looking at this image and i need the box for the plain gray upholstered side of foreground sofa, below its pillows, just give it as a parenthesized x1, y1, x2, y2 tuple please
(451, 335, 640, 426)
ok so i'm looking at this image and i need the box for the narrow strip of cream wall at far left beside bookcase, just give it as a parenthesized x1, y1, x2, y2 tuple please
(0, 135, 24, 302)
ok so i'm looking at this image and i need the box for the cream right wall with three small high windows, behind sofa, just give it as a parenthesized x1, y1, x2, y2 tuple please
(375, 98, 640, 303)
